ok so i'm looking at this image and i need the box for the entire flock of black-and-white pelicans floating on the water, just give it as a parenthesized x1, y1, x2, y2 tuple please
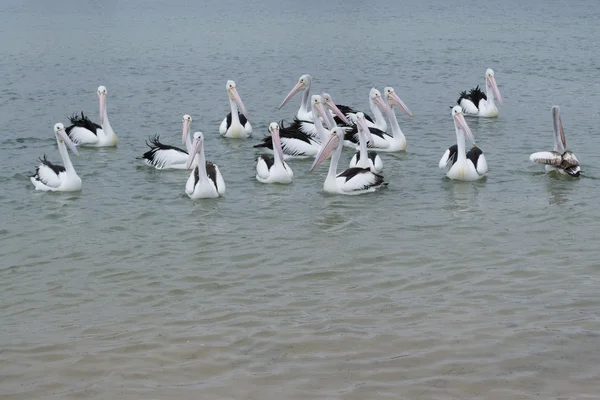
(30, 69, 581, 199)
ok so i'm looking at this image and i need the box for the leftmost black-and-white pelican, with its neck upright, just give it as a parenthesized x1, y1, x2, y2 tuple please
(29, 123, 81, 192)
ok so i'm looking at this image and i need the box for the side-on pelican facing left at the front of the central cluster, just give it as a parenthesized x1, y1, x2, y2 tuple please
(310, 127, 387, 195)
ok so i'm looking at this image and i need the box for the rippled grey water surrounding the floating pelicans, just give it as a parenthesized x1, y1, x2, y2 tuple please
(0, 0, 600, 400)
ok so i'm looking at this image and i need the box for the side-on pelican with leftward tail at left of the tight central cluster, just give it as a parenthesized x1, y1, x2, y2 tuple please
(254, 95, 327, 159)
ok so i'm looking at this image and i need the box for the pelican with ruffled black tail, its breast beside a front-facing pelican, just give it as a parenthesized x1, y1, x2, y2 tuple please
(141, 114, 195, 169)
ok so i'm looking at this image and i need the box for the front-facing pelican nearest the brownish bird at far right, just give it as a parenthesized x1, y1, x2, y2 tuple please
(439, 106, 488, 181)
